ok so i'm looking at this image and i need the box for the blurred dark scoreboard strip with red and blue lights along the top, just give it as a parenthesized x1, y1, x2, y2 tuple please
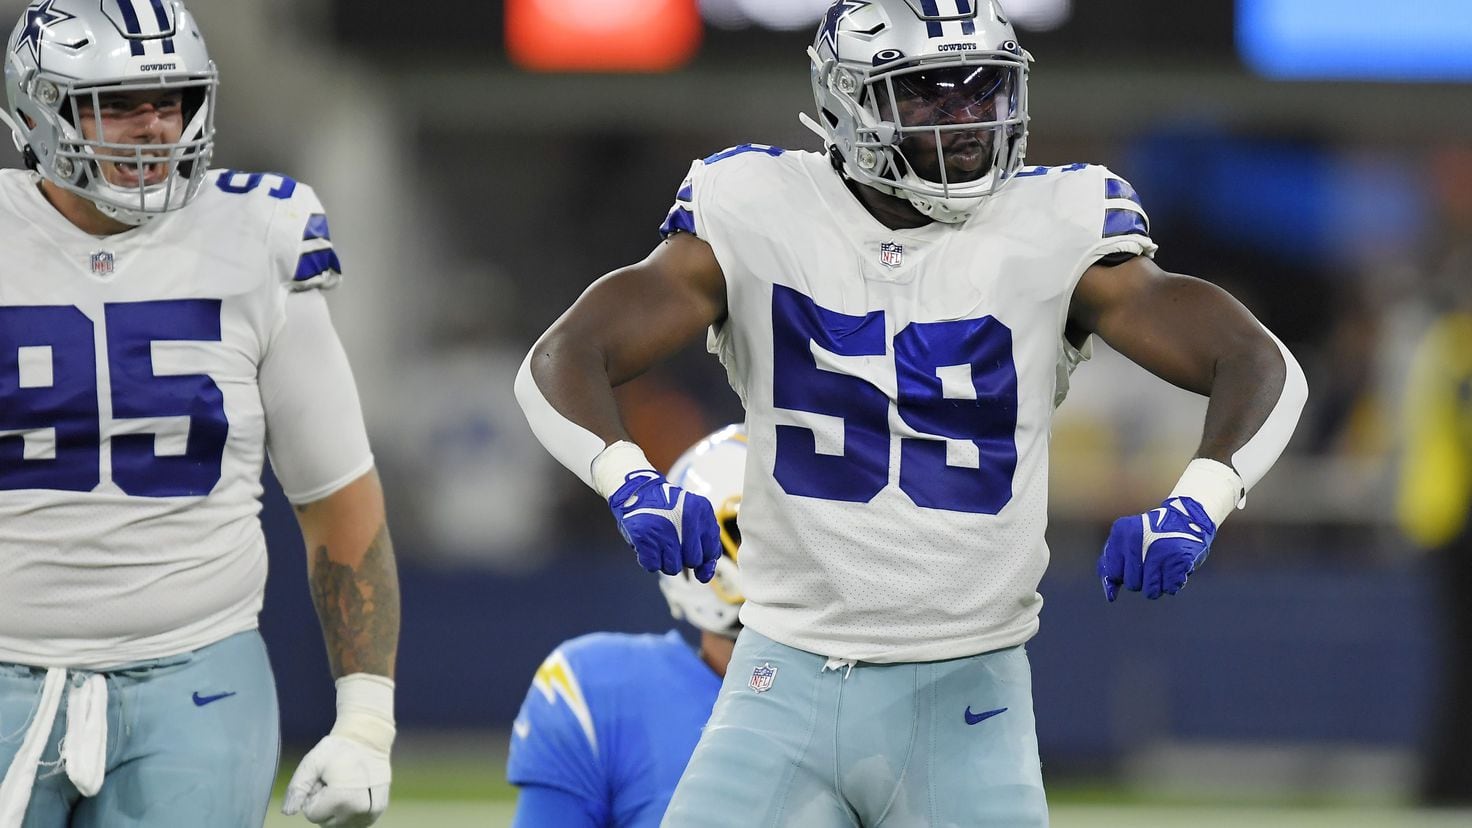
(330, 0, 1472, 81)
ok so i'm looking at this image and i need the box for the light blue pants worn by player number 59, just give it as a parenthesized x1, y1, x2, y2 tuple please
(662, 629, 1048, 828)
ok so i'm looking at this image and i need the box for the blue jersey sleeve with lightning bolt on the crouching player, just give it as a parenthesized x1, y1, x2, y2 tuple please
(506, 647, 608, 815)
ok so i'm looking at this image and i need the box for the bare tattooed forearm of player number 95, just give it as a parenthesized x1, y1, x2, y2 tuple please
(296, 470, 399, 678)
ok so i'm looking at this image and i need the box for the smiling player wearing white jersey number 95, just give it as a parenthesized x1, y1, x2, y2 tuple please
(0, 0, 399, 828)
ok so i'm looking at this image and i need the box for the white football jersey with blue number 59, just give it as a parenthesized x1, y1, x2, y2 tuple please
(662, 144, 1156, 662)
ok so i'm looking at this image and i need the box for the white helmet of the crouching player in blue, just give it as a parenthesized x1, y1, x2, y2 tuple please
(659, 426, 746, 638)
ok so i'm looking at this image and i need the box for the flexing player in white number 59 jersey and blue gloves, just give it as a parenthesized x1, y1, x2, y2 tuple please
(517, 0, 1307, 828)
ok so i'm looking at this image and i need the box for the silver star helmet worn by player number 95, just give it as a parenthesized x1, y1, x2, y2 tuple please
(0, 0, 219, 225)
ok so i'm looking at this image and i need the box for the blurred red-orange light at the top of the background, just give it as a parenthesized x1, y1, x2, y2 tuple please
(506, 0, 702, 72)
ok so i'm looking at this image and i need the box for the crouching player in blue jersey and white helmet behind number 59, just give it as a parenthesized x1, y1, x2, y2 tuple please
(506, 426, 746, 828)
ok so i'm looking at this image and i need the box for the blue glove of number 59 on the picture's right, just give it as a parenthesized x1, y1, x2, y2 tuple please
(1098, 489, 1216, 601)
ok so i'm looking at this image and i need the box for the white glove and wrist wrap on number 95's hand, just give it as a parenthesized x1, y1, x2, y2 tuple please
(281, 673, 394, 828)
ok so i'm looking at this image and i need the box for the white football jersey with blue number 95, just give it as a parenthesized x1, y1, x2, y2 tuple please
(0, 169, 372, 669)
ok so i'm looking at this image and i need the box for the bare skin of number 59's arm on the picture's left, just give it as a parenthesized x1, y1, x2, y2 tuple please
(528, 233, 726, 450)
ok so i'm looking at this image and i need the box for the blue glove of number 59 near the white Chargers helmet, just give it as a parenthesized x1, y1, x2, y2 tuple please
(608, 471, 721, 583)
